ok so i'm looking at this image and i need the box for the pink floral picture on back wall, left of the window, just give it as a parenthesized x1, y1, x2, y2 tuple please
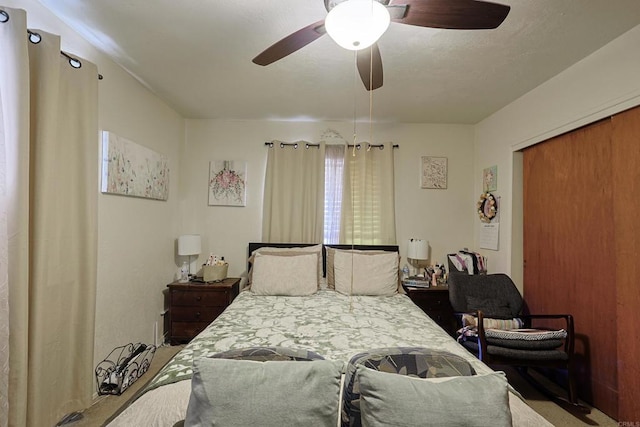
(209, 160, 247, 206)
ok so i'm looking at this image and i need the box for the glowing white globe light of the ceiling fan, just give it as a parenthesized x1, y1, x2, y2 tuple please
(324, 0, 391, 50)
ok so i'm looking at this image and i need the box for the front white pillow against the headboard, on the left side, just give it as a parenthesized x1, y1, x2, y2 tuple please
(251, 253, 318, 296)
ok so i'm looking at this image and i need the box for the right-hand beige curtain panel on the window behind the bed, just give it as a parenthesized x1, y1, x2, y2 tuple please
(340, 143, 396, 245)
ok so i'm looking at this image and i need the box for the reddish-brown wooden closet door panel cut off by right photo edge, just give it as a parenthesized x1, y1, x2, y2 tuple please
(611, 107, 640, 421)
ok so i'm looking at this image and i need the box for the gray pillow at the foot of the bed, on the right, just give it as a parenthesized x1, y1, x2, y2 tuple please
(356, 366, 511, 427)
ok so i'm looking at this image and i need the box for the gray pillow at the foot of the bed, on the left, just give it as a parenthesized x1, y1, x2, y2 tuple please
(185, 358, 343, 427)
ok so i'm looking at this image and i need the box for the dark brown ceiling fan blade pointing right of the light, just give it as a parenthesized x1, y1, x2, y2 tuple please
(391, 0, 511, 30)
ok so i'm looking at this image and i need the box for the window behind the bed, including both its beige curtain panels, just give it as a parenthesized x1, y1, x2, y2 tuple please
(262, 141, 396, 245)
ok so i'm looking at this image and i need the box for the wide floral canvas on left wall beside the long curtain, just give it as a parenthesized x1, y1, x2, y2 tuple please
(101, 131, 169, 200)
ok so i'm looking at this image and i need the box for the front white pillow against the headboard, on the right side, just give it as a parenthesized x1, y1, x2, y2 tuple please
(333, 251, 398, 296)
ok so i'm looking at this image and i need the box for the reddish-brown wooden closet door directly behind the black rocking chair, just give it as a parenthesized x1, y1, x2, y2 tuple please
(523, 119, 618, 418)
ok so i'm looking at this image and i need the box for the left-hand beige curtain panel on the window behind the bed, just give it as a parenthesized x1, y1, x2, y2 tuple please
(262, 141, 325, 243)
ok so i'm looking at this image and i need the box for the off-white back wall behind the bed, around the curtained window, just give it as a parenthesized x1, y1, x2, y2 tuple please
(184, 120, 474, 276)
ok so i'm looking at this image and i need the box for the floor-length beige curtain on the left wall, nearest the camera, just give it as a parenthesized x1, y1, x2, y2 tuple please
(0, 8, 98, 426)
